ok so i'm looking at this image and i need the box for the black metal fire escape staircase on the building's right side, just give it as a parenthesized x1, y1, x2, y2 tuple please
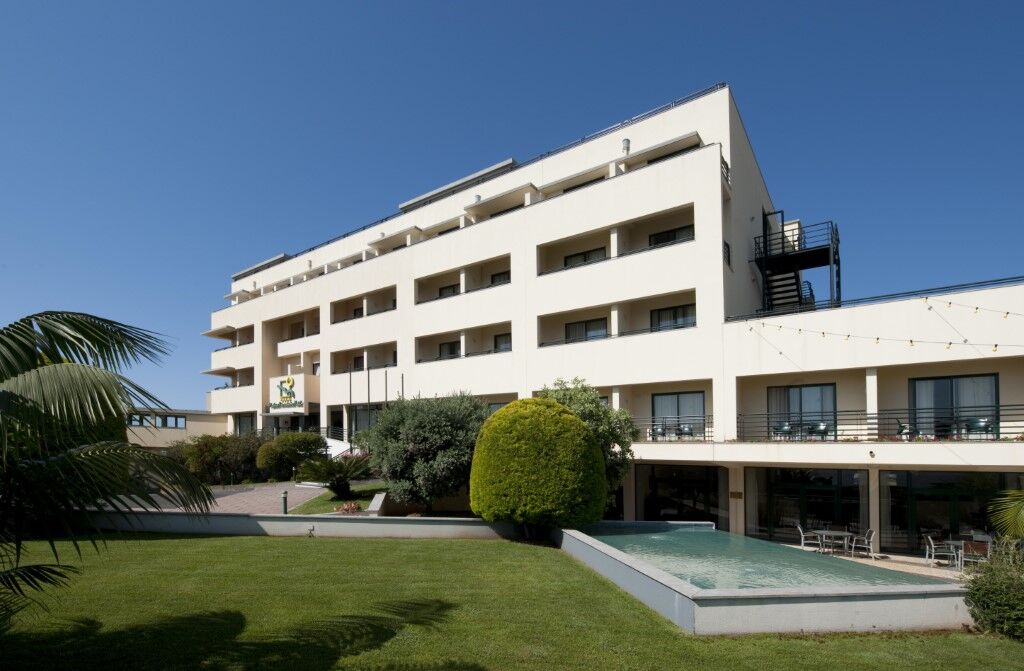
(754, 210, 843, 312)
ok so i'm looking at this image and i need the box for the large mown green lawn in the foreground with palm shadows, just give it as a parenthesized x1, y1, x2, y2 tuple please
(0, 537, 1024, 671)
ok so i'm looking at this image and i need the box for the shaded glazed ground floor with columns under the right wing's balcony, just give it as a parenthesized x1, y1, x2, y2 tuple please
(622, 462, 1024, 554)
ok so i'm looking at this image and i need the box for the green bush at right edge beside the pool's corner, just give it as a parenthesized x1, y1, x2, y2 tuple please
(965, 540, 1024, 640)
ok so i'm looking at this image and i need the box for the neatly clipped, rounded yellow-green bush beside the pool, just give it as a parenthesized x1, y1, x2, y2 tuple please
(469, 399, 607, 536)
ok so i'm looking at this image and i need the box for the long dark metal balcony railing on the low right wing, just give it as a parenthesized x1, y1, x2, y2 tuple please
(736, 406, 1024, 443)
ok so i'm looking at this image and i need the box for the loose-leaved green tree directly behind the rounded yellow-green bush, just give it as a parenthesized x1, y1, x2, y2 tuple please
(538, 377, 640, 494)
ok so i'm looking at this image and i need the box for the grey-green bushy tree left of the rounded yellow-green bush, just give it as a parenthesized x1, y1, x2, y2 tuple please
(353, 392, 487, 511)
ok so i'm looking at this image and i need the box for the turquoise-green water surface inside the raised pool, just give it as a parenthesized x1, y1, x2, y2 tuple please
(587, 522, 949, 589)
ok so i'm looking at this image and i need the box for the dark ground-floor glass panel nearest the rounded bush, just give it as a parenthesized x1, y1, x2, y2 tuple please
(635, 464, 729, 530)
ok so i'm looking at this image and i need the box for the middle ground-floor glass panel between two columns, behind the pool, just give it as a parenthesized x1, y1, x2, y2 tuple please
(744, 468, 868, 542)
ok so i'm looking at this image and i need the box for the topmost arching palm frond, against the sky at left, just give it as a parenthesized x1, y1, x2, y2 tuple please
(0, 310, 168, 380)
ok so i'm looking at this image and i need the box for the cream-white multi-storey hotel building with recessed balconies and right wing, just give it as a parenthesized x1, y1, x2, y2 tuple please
(206, 85, 1024, 551)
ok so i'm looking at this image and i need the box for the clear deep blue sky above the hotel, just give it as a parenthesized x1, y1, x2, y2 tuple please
(0, 0, 1024, 408)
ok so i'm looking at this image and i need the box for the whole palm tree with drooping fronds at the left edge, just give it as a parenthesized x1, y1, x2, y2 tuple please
(0, 311, 213, 628)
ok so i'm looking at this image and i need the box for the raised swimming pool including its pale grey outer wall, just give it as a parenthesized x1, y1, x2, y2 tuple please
(554, 522, 972, 634)
